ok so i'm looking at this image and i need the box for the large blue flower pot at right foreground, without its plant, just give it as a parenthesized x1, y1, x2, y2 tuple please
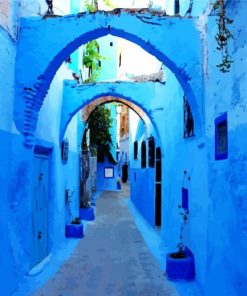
(166, 247, 195, 281)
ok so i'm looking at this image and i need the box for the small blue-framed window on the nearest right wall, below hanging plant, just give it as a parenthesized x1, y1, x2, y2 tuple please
(215, 113, 228, 160)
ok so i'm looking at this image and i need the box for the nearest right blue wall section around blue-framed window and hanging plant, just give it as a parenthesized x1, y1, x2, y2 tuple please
(201, 1, 247, 296)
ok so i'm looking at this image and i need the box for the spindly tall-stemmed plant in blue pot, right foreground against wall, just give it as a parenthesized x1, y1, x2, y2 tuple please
(166, 206, 195, 281)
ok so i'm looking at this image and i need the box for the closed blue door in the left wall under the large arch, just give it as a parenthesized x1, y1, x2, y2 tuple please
(31, 155, 48, 268)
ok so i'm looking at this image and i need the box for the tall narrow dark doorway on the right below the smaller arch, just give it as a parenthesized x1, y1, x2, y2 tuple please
(155, 147, 162, 227)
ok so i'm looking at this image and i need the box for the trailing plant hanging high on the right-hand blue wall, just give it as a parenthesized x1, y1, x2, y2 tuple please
(213, 0, 233, 73)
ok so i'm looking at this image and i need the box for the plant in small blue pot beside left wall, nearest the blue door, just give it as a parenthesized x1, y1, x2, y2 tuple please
(65, 189, 83, 238)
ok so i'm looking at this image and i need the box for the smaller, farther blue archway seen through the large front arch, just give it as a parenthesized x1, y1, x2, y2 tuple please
(60, 81, 165, 143)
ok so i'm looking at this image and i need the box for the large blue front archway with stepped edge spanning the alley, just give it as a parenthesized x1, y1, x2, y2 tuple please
(15, 10, 202, 146)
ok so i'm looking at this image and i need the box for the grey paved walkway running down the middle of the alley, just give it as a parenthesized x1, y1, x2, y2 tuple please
(33, 187, 178, 296)
